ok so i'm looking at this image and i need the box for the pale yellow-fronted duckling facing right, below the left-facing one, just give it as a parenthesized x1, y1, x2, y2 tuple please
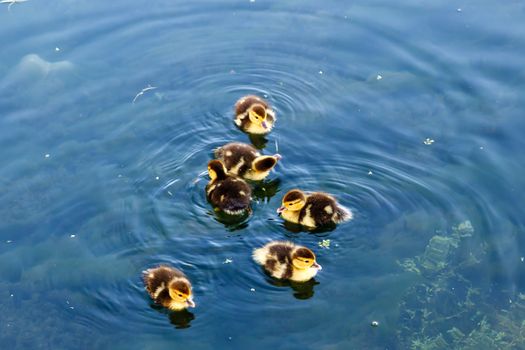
(252, 241, 322, 282)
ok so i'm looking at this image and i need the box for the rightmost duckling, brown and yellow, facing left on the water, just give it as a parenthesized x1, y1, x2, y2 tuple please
(277, 190, 353, 228)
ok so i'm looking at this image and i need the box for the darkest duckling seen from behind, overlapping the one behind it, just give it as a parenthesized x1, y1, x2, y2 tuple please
(206, 159, 252, 215)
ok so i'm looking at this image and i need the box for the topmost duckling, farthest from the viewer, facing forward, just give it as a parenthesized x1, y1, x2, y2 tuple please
(235, 95, 276, 134)
